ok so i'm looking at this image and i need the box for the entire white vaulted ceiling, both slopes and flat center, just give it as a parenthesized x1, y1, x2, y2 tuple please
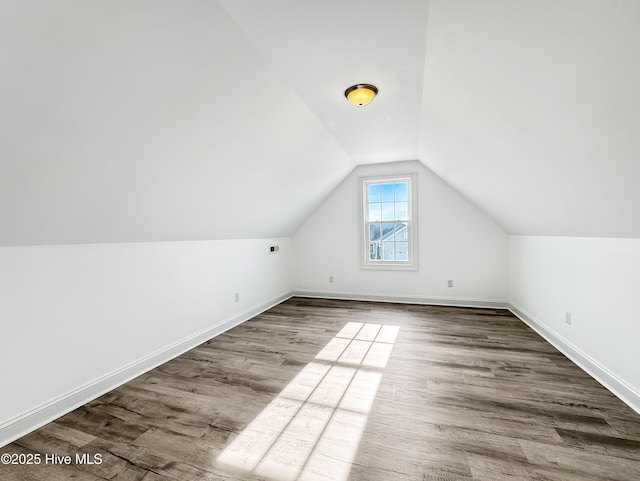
(0, 0, 640, 245)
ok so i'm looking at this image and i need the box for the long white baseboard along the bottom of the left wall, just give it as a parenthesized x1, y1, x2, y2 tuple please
(0, 292, 293, 447)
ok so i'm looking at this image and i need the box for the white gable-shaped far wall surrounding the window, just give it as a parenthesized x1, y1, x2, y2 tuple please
(293, 162, 508, 303)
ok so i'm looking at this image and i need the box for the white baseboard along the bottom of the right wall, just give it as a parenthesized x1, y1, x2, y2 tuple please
(508, 303, 640, 414)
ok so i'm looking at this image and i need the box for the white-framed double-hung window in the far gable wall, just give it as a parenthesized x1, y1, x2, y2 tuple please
(361, 174, 418, 270)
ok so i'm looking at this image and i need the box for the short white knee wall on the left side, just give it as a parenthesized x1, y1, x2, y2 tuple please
(0, 238, 291, 445)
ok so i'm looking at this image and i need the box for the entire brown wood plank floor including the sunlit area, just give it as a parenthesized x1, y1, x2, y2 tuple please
(0, 298, 640, 481)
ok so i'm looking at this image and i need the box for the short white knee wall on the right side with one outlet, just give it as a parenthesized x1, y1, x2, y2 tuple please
(509, 236, 640, 412)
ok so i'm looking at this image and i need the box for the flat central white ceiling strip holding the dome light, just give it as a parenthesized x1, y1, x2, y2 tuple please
(220, 0, 427, 164)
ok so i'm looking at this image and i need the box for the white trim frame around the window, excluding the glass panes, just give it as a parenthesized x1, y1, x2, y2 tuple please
(358, 172, 419, 271)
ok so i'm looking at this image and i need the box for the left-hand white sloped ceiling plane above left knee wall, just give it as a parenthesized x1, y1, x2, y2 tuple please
(0, 0, 355, 245)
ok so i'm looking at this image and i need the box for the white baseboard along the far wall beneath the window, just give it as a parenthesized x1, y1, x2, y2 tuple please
(293, 289, 509, 309)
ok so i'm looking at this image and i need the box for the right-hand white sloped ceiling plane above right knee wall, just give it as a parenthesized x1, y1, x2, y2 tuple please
(420, 0, 640, 237)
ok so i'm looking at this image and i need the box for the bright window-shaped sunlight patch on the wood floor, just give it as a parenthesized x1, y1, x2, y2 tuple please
(218, 322, 399, 481)
